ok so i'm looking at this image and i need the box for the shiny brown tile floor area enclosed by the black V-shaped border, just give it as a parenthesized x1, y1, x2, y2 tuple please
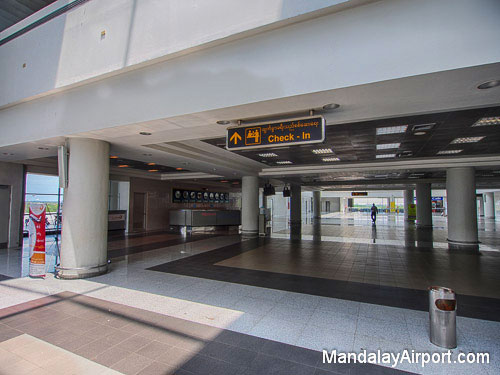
(216, 238, 500, 298)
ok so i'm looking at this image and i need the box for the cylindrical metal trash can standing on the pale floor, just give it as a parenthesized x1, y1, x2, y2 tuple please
(429, 286, 457, 349)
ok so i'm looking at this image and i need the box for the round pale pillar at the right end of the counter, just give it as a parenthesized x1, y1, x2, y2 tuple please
(241, 176, 259, 238)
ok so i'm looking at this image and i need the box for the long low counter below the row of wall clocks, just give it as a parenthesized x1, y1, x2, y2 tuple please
(170, 209, 241, 227)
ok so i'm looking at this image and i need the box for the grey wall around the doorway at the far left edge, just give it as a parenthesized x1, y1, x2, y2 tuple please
(0, 162, 25, 248)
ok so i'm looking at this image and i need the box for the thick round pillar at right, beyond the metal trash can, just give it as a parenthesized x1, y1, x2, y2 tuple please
(446, 167, 479, 248)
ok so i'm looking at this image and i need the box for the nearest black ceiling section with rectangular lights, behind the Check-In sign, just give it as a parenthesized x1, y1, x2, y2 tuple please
(205, 107, 500, 166)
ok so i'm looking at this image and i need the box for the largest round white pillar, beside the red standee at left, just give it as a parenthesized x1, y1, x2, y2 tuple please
(58, 138, 109, 279)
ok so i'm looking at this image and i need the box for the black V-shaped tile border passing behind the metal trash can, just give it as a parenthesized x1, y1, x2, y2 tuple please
(148, 239, 500, 321)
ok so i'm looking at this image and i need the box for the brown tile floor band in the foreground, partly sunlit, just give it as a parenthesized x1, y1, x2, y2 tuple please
(0, 292, 411, 375)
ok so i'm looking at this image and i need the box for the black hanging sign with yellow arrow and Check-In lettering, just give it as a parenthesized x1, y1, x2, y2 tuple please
(226, 116, 325, 150)
